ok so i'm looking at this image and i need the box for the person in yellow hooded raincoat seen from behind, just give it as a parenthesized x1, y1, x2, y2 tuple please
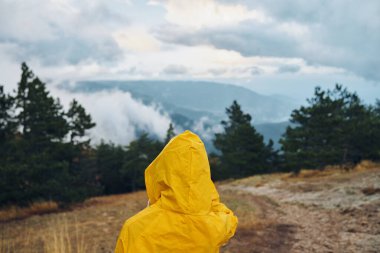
(115, 130, 237, 253)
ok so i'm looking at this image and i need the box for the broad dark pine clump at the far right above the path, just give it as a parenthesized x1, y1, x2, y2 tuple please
(280, 85, 376, 172)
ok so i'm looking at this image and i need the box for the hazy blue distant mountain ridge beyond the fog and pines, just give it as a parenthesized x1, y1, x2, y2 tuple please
(64, 81, 295, 121)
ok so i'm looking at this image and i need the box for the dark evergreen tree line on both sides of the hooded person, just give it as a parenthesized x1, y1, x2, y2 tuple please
(0, 63, 380, 206)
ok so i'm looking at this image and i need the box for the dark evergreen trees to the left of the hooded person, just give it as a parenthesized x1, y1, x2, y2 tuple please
(0, 63, 174, 206)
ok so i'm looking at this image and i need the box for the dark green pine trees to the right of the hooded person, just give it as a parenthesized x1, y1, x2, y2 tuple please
(210, 84, 380, 179)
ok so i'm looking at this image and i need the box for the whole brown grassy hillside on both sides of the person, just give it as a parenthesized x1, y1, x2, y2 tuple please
(0, 162, 380, 253)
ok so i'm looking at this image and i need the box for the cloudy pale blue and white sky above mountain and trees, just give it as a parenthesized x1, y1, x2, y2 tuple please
(0, 0, 380, 142)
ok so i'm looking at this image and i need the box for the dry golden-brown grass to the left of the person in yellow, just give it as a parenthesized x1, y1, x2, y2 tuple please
(0, 192, 146, 253)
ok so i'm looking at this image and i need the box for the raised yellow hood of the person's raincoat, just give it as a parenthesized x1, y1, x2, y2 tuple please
(145, 130, 214, 214)
